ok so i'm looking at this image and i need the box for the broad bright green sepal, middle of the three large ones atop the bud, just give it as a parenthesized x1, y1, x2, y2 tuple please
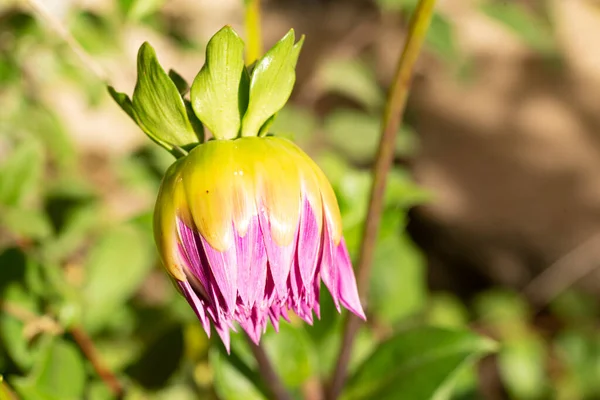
(190, 26, 248, 139)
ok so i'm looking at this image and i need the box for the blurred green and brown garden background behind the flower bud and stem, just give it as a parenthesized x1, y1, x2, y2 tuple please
(0, 0, 600, 400)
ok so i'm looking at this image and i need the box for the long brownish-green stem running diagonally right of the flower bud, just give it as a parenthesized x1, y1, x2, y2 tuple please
(326, 0, 435, 400)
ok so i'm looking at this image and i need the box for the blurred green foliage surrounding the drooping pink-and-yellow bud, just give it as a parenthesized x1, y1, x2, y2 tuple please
(0, 0, 600, 400)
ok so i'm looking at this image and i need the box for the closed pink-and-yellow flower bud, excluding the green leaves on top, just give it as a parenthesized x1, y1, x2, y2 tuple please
(154, 137, 365, 348)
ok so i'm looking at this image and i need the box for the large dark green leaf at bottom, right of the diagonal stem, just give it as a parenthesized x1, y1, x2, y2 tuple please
(342, 327, 495, 400)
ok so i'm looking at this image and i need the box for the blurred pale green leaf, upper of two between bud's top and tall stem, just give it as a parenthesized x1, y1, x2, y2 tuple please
(319, 59, 385, 111)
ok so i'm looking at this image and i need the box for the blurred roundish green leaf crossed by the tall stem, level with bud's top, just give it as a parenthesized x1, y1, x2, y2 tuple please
(324, 109, 417, 163)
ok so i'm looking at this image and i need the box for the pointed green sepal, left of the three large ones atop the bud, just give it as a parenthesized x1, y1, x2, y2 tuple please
(132, 42, 198, 150)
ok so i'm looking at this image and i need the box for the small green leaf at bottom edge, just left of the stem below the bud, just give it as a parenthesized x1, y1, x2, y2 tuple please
(210, 346, 266, 400)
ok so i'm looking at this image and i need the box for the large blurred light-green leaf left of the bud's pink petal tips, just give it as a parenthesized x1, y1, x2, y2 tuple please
(82, 226, 154, 331)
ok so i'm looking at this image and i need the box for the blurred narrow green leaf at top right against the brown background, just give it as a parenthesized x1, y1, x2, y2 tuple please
(480, 1, 556, 54)
